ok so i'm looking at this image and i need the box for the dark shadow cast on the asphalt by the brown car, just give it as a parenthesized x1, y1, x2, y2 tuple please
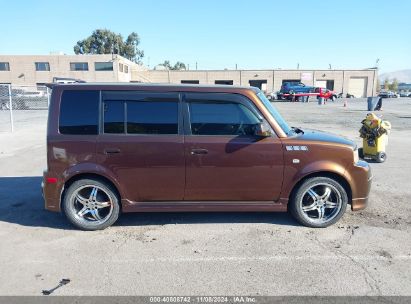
(0, 176, 299, 230)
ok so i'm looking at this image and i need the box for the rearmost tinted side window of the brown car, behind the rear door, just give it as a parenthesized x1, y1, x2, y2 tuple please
(59, 90, 100, 135)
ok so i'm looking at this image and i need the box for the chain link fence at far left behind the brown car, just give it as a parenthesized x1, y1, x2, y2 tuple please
(0, 84, 50, 132)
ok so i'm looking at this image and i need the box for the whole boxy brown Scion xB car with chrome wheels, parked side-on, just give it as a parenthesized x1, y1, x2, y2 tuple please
(43, 83, 372, 230)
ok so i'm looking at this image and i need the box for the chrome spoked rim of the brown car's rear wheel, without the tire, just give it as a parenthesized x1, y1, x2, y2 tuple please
(69, 185, 113, 224)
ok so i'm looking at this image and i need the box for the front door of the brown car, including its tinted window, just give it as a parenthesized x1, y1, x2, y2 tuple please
(184, 93, 283, 201)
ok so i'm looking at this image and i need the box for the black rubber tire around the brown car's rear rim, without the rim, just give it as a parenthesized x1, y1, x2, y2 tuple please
(62, 179, 120, 231)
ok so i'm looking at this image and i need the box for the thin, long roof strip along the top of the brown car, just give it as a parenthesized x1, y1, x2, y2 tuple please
(47, 82, 260, 93)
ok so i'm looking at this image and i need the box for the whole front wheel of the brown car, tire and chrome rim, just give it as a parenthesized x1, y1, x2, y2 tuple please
(289, 177, 348, 228)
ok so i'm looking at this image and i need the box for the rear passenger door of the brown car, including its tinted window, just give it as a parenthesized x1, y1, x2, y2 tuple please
(97, 91, 185, 201)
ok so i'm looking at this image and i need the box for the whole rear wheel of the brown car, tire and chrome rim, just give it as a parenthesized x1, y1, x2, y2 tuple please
(63, 179, 120, 230)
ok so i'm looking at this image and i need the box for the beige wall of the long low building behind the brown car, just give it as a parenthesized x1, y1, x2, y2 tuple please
(0, 54, 378, 96)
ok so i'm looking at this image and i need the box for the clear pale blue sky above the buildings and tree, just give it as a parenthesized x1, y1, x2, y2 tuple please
(0, 0, 411, 72)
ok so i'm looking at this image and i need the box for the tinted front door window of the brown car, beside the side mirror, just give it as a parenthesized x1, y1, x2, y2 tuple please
(188, 100, 261, 136)
